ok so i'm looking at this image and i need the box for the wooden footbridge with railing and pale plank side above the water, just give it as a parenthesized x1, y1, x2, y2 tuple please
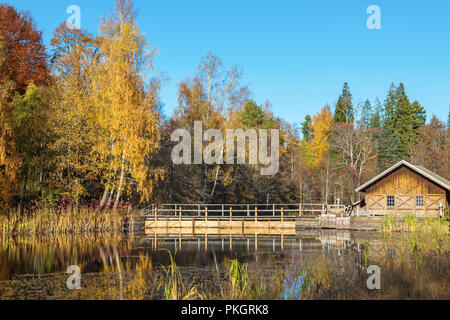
(143, 204, 346, 236)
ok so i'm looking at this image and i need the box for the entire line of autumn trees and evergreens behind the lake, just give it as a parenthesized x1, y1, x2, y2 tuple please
(0, 0, 450, 209)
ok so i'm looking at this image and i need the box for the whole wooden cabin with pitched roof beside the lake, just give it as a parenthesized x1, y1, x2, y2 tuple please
(353, 161, 450, 217)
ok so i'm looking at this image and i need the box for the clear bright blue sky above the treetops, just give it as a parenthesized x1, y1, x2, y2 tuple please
(6, 0, 450, 123)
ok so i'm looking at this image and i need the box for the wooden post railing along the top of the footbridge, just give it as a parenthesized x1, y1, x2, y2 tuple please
(143, 203, 345, 217)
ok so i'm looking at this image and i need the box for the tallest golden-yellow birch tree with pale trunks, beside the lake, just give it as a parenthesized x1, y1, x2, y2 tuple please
(91, 0, 163, 208)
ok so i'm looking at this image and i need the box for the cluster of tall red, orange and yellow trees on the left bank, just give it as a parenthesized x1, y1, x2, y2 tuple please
(0, 1, 163, 207)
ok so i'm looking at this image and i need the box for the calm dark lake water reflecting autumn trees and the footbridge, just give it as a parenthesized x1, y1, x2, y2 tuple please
(0, 230, 390, 299)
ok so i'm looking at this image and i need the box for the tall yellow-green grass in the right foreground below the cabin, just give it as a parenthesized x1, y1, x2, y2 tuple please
(302, 217, 450, 300)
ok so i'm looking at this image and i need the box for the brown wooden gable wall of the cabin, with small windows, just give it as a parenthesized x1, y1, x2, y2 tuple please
(365, 166, 447, 217)
